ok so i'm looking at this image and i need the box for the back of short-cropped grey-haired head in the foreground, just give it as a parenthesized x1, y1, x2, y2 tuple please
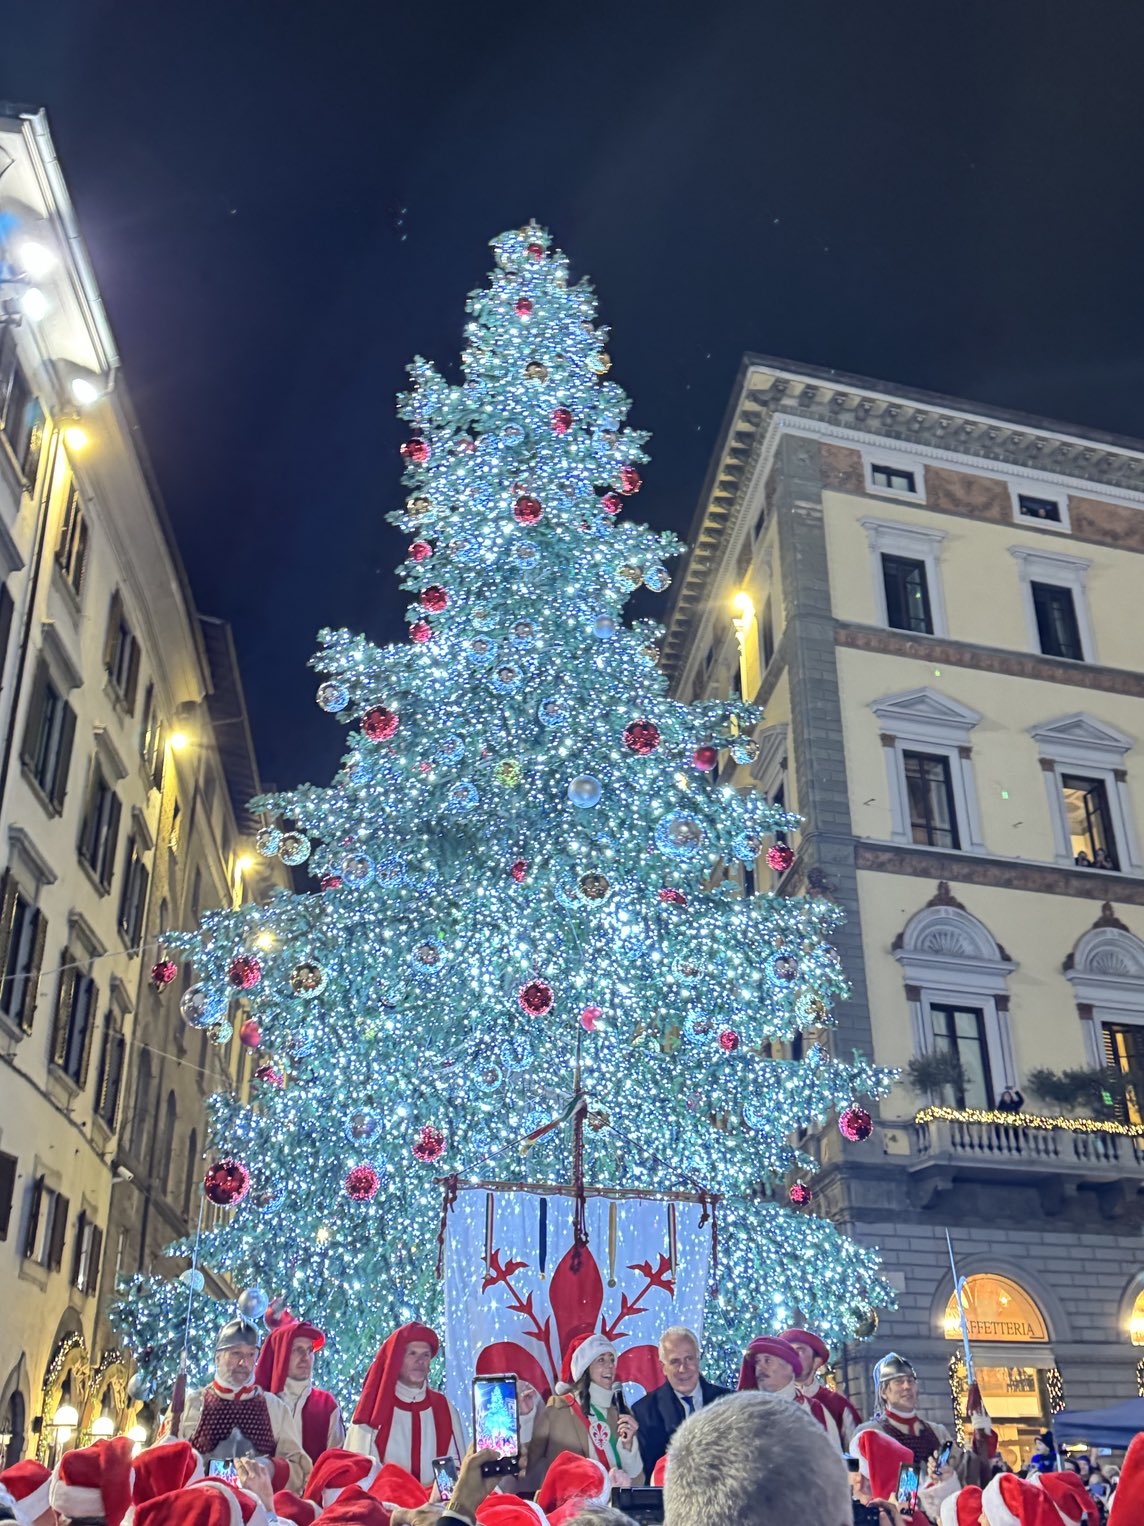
(664, 1390, 854, 1526)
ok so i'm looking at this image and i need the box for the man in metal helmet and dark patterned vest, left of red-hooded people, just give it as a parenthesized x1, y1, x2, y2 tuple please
(160, 1318, 310, 1491)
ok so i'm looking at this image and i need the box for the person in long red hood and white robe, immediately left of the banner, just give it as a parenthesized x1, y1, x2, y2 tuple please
(346, 1323, 465, 1485)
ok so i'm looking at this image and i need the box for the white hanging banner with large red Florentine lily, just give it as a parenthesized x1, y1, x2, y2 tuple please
(445, 1187, 711, 1415)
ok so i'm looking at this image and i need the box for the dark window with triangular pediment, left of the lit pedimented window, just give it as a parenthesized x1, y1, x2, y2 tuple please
(871, 688, 985, 853)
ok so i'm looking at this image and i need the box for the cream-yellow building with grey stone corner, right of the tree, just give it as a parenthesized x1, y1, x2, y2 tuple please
(664, 357, 1144, 1456)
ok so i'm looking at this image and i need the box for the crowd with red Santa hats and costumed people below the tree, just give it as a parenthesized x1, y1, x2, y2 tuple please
(0, 1318, 1144, 1526)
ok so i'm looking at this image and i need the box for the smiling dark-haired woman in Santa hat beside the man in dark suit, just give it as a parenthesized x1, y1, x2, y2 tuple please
(522, 1331, 644, 1494)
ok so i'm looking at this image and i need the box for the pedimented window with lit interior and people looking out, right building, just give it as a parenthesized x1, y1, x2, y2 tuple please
(1030, 714, 1144, 874)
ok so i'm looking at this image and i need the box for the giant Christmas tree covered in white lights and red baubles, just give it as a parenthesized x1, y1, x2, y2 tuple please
(116, 227, 892, 1393)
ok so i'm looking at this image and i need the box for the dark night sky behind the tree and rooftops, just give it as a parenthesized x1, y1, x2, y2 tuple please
(0, 0, 1144, 786)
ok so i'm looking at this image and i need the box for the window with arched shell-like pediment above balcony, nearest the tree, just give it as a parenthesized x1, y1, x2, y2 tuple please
(894, 881, 1017, 1108)
